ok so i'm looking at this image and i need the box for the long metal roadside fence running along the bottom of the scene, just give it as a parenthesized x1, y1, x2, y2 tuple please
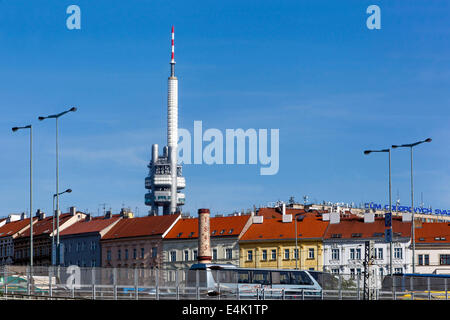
(0, 266, 448, 300)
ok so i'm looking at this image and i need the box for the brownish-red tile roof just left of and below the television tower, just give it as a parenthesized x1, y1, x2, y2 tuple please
(102, 214, 180, 240)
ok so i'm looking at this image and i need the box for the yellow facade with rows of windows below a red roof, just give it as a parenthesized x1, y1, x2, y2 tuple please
(239, 239, 323, 271)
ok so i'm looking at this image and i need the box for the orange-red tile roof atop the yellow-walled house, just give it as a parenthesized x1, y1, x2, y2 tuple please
(241, 210, 328, 241)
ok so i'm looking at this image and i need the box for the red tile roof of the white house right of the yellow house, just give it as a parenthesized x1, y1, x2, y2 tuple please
(324, 216, 411, 239)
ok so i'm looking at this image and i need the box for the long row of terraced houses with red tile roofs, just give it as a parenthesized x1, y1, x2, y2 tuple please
(0, 207, 450, 275)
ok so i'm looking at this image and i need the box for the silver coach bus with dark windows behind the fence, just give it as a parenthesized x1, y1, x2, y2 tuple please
(186, 263, 322, 298)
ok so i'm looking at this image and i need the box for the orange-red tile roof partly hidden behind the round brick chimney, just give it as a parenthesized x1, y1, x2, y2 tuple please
(164, 215, 250, 239)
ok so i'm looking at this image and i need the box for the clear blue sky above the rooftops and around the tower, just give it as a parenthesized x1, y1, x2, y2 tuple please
(0, 0, 450, 215)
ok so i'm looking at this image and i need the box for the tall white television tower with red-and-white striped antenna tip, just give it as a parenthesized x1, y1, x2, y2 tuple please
(145, 26, 186, 215)
